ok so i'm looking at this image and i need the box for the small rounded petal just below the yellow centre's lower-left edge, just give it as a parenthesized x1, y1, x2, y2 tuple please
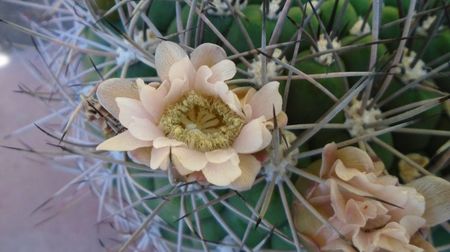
(172, 147, 207, 171)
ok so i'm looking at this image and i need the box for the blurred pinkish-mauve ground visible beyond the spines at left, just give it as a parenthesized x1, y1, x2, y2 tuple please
(0, 49, 105, 252)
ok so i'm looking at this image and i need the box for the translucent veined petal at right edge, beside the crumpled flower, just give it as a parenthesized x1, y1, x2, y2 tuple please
(407, 176, 450, 227)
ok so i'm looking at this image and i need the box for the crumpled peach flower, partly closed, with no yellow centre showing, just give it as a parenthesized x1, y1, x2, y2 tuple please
(294, 144, 429, 252)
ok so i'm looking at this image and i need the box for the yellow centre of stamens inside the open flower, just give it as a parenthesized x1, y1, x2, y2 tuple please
(160, 91, 244, 151)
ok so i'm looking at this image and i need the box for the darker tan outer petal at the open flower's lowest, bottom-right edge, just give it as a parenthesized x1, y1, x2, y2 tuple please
(230, 155, 261, 191)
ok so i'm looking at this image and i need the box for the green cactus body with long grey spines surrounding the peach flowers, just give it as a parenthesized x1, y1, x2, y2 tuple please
(3, 0, 450, 251)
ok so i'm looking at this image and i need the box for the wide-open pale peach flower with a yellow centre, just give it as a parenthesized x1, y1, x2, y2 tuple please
(97, 42, 282, 190)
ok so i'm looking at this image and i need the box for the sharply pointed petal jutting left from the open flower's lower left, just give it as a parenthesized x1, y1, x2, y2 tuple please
(97, 130, 152, 151)
